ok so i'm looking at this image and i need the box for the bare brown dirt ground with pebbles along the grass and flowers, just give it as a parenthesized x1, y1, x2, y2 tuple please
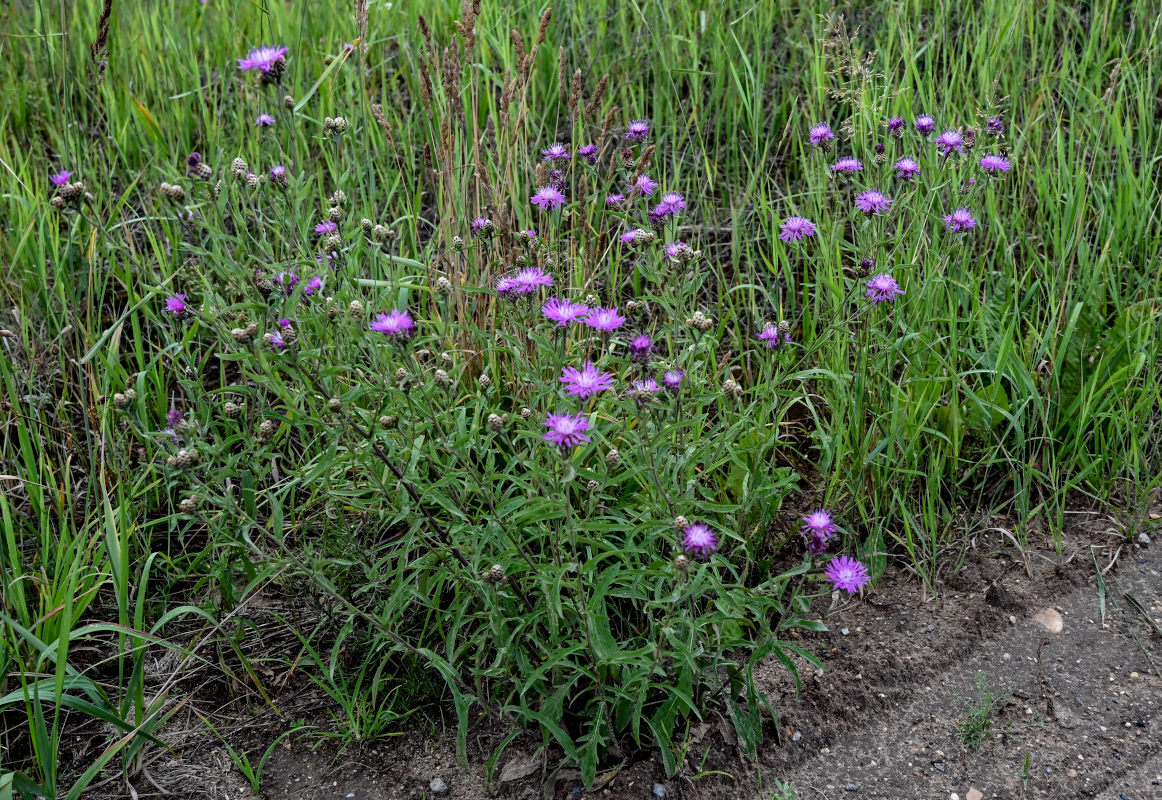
(129, 509, 1162, 800)
